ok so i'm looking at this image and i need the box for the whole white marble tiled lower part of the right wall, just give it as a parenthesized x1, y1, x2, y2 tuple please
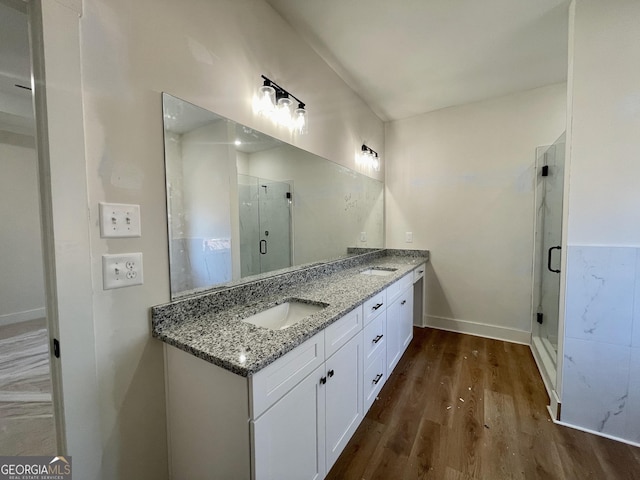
(562, 246, 640, 443)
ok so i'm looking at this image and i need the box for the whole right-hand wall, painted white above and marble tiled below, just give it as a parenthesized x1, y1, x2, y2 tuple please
(561, 0, 640, 444)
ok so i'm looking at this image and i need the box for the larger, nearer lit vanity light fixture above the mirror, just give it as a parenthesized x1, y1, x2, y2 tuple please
(253, 75, 307, 134)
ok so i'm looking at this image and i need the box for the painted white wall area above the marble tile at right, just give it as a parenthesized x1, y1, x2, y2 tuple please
(567, 0, 640, 246)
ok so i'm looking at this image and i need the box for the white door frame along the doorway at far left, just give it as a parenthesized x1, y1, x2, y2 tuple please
(25, 0, 102, 472)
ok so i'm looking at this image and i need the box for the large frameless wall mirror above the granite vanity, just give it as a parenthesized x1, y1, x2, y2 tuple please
(162, 93, 384, 299)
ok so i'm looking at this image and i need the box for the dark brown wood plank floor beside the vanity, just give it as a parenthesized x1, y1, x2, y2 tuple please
(327, 328, 640, 480)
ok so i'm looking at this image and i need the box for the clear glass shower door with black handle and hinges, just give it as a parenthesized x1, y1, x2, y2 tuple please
(533, 135, 565, 368)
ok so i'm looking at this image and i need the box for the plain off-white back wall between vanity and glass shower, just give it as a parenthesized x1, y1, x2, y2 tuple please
(385, 84, 566, 342)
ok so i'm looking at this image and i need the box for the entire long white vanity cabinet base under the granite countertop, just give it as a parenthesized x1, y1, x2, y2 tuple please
(165, 272, 422, 480)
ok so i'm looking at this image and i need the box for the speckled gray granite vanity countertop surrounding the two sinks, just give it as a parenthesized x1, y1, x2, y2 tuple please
(152, 253, 428, 377)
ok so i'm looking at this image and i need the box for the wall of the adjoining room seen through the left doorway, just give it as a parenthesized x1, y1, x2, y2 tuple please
(0, 130, 45, 325)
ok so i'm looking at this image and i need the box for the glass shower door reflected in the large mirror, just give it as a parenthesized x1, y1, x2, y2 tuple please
(238, 174, 292, 277)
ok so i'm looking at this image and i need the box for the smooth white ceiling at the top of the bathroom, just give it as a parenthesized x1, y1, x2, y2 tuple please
(266, 0, 569, 121)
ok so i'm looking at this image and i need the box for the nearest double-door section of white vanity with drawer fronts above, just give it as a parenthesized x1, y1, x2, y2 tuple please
(251, 307, 364, 480)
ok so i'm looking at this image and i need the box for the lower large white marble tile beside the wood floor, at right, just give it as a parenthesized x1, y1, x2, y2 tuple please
(562, 338, 631, 437)
